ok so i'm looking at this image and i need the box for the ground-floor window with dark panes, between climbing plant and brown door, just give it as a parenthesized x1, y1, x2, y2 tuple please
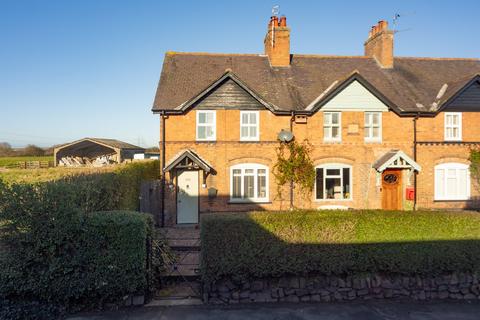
(315, 164, 352, 200)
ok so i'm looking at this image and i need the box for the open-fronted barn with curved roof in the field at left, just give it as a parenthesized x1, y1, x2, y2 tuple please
(53, 138, 145, 166)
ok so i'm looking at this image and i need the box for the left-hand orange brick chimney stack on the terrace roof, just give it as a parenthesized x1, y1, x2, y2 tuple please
(263, 16, 290, 67)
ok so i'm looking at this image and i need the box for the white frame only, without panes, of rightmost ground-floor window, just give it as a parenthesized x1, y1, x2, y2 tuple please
(434, 162, 470, 200)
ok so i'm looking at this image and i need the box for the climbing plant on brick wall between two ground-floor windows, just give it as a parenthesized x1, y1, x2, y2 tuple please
(273, 140, 315, 198)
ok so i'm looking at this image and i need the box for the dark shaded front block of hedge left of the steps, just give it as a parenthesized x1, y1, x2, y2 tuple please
(0, 209, 153, 319)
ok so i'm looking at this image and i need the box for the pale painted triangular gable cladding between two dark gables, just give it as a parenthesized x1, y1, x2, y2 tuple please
(320, 80, 388, 111)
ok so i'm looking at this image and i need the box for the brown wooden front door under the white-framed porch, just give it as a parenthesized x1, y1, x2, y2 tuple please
(382, 169, 403, 210)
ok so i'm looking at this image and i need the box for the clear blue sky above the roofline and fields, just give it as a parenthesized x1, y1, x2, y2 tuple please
(0, 0, 480, 146)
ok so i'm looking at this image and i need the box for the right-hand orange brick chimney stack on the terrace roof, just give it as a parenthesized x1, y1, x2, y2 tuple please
(365, 20, 393, 69)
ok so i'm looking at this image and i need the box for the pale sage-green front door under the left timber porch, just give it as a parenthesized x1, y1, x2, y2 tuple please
(177, 171, 198, 223)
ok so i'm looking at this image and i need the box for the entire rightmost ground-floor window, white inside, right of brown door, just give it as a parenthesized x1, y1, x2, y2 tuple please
(435, 163, 470, 200)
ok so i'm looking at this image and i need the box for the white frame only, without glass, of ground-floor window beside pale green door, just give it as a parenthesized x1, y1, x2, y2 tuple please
(230, 163, 270, 203)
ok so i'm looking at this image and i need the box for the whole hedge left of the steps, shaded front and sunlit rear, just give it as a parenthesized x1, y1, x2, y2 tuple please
(0, 162, 159, 319)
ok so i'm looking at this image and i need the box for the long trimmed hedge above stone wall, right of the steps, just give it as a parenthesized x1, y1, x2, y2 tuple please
(201, 211, 480, 283)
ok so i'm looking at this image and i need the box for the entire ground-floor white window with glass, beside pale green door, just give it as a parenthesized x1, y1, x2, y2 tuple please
(230, 163, 268, 202)
